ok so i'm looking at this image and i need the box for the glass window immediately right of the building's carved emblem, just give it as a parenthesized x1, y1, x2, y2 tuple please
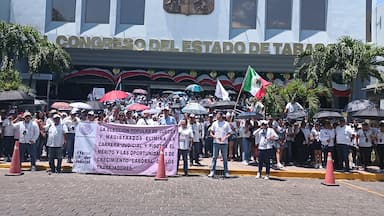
(231, 0, 257, 29)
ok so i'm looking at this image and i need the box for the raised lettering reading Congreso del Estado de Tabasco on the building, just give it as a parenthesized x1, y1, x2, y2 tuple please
(56, 35, 325, 55)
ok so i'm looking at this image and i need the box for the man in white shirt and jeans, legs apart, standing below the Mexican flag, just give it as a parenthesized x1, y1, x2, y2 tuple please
(208, 112, 232, 178)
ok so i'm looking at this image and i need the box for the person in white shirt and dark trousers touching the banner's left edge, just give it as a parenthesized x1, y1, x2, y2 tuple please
(63, 110, 80, 163)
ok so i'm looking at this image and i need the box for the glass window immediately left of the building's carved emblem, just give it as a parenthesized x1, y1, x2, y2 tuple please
(120, 0, 145, 25)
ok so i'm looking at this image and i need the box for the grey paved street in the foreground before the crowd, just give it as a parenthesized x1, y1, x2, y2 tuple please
(0, 169, 384, 215)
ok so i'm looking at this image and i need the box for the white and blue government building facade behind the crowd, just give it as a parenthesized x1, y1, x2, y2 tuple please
(0, 0, 373, 103)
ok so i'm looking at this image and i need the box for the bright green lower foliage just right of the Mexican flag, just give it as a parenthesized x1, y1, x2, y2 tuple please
(263, 79, 331, 117)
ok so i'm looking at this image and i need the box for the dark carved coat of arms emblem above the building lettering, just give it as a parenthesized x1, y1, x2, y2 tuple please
(163, 0, 214, 15)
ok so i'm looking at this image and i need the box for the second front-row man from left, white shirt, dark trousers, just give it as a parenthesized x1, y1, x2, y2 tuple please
(47, 114, 68, 174)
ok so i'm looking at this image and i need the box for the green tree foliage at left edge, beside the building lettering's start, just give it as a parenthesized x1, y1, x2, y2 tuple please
(0, 22, 71, 89)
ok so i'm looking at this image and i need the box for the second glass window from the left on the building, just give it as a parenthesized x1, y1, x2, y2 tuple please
(85, 0, 110, 24)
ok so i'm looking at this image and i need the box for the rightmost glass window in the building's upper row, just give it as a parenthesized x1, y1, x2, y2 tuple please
(300, 0, 327, 31)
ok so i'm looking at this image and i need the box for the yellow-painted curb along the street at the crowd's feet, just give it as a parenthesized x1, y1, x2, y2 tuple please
(0, 164, 384, 181)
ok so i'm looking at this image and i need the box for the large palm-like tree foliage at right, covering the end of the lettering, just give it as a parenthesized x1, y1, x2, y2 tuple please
(295, 37, 384, 87)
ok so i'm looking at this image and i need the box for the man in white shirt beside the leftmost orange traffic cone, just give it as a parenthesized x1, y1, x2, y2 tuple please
(15, 112, 40, 171)
